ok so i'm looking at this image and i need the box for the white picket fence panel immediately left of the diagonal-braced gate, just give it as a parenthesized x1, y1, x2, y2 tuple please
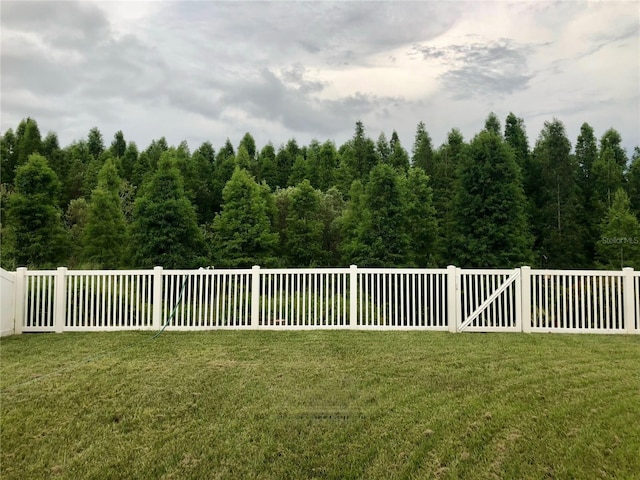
(355, 268, 449, 330)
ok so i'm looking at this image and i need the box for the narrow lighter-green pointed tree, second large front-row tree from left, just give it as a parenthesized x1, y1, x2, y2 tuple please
(82, 158, 126, 269)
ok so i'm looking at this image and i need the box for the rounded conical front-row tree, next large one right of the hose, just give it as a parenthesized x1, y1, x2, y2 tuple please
(212, 168, 278, 267)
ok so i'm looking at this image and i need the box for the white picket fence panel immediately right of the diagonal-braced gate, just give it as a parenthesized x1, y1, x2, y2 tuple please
(531, 270, 624, 333)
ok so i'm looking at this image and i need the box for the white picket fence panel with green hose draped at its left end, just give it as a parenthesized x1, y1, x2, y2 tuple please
(161, 269, 251, 330)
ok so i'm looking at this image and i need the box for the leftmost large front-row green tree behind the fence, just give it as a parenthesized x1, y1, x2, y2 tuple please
(7, 154, 69, 268)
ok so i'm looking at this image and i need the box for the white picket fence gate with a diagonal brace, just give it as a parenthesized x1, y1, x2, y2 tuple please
(456, 268, 522, 332)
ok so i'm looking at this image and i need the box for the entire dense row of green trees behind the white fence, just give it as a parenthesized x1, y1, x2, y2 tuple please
(0, 113, 640, 270)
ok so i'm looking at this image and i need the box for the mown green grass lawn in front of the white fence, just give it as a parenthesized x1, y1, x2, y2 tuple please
(0, 331, 640, 480)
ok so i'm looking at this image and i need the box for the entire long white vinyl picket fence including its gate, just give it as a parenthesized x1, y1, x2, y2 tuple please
(2, 265, 640, 334)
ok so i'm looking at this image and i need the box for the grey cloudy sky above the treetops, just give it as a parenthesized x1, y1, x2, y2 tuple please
(0, 0, 640, 153)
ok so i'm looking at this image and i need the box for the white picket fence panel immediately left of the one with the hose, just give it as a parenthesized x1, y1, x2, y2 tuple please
(64, 270, 154, 331)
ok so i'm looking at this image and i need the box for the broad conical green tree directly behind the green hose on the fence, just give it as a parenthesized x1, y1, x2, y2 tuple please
(129, 152, 206, 268)
